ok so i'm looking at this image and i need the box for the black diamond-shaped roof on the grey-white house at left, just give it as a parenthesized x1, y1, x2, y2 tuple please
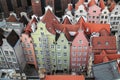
(7, 30, 19, 47)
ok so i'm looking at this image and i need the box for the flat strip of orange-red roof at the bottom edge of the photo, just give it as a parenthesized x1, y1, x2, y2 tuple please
(45, 75, 85, 80)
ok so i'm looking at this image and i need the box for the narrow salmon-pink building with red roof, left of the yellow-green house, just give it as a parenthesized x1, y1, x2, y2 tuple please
(21, 17, 37, 69)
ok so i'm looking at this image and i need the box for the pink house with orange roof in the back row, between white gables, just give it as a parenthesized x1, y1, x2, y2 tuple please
(88, 0, 101, 23)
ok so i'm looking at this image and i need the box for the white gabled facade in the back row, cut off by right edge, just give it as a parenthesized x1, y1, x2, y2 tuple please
(110, 5, 120, 32)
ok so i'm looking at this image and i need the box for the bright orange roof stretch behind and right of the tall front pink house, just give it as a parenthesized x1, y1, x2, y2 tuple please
(83, 22, 110, 34)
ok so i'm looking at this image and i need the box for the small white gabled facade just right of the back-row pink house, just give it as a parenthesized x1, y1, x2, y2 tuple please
(100, 7, 110, 24)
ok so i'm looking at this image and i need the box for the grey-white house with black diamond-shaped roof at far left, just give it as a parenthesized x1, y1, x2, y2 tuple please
(0, 30, 26, 71)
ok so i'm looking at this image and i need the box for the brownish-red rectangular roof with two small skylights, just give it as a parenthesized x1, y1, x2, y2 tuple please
(92, 36, 116, 50)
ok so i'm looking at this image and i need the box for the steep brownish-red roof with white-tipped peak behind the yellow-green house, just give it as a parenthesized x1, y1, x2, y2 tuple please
(41, 9, 59, 34)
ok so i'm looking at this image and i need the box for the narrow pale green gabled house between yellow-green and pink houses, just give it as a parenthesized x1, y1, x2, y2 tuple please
(55, 30, 70, 72)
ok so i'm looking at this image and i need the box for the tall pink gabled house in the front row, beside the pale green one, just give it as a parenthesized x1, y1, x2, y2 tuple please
(70, 30, 89, 71)
